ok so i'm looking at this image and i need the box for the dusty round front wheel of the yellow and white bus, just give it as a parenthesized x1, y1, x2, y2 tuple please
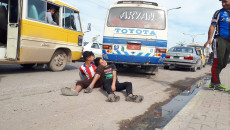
(48, 50, 67, 71)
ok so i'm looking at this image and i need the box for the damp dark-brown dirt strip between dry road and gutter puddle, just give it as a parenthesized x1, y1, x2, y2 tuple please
(119, 75, 207, 130)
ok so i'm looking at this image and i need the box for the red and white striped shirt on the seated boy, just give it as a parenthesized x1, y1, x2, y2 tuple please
(79, 63, 96, 79)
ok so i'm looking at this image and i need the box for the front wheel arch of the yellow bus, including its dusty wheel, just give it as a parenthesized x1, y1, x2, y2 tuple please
(48, 48, 72, 71)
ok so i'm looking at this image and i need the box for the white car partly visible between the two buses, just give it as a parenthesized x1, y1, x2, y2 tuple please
(83, 42, 102, 58)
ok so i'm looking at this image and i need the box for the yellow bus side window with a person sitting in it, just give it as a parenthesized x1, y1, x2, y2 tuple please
(46, 3, 59, 25)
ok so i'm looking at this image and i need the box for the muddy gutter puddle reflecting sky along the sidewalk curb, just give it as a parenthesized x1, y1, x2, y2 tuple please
(120, 77, 210, 130)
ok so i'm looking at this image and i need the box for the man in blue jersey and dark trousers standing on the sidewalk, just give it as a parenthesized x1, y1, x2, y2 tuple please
(204, 0, 230, 91)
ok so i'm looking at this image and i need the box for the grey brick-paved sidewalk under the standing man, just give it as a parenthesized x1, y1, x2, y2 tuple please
(164, 64, 230, 130)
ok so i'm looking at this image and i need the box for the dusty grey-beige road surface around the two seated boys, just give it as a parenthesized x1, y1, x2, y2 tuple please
(0, 62, 210, 130)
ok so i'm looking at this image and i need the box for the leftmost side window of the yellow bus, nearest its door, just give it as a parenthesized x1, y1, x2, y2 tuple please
(28, 0, 46, 21)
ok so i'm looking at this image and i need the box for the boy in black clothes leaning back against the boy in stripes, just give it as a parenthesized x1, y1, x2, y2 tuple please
(94, 58, 144, 103)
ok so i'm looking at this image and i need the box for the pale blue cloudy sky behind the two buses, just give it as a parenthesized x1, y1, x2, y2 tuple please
(60, 0, 222, 48)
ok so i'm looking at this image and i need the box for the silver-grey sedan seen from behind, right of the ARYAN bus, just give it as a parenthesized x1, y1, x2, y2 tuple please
(164, 46, 202, 72)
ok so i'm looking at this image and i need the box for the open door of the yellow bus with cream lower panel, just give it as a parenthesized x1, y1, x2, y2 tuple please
(6, 0, 21, 60)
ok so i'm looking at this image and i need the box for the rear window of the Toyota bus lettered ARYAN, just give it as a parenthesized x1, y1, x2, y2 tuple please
(107, 7, 166, 30)
